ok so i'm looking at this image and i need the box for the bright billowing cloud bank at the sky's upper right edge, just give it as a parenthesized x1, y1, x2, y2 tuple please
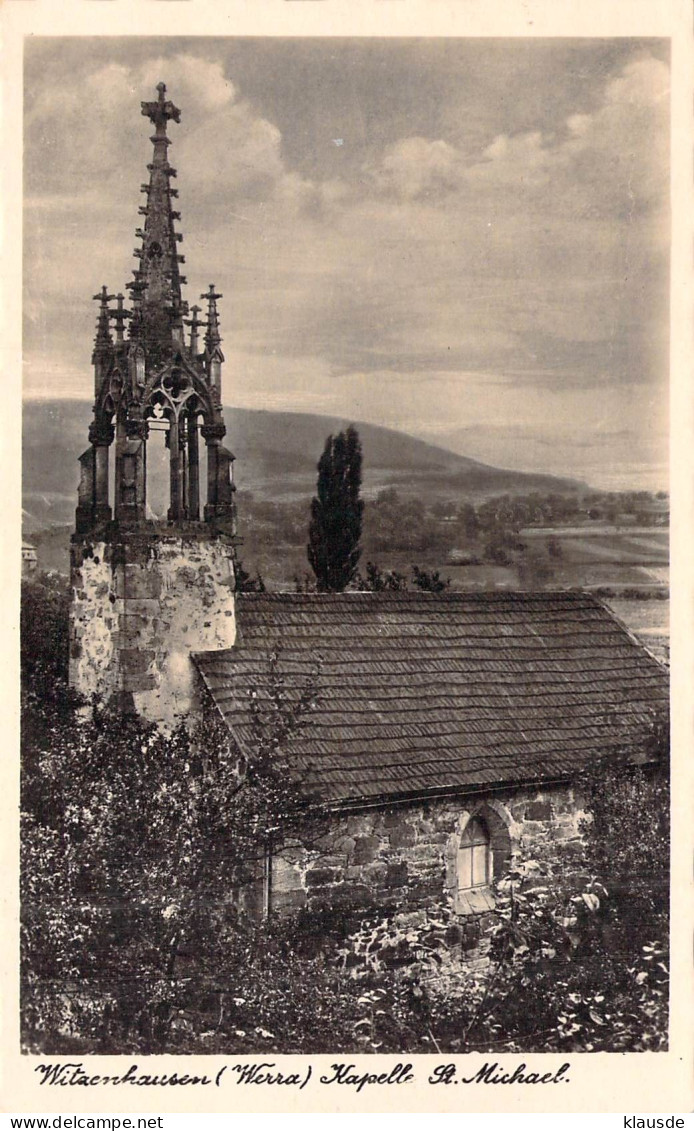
(367, 58, 669, 218)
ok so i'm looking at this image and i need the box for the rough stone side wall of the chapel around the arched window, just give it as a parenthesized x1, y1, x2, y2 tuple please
(271, 786, 585, 915)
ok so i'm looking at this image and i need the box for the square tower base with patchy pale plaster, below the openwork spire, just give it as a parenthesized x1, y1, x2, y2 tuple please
(70, 533, 236, 727)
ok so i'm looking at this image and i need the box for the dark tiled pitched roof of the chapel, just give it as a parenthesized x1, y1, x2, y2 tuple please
(193, 593, 668, 803)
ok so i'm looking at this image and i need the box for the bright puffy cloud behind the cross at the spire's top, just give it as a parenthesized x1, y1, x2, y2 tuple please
(26, 54, 284, 203)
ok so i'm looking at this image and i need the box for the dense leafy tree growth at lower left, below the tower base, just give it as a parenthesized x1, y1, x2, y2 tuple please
(20, 579, 322, 1052)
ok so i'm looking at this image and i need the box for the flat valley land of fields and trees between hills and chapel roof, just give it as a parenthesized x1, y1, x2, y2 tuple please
(25, 492, 669, 658)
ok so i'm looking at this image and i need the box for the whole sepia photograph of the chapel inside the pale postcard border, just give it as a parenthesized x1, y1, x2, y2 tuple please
(23, 33, 671, 1067)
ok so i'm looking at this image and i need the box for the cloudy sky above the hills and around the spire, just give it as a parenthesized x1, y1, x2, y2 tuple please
(24, 36, 670, 490)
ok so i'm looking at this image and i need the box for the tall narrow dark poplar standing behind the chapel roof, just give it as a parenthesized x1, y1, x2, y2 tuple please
(307, 425, 364, 593)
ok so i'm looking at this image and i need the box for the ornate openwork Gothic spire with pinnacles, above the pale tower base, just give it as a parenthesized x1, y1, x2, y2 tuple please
(76, 83, 236, 537)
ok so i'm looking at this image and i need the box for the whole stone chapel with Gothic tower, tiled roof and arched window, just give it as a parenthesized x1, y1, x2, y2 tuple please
(70, 83, 668, 918)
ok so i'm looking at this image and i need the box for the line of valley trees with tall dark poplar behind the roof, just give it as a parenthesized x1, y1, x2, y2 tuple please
(229, 428, 667, 592)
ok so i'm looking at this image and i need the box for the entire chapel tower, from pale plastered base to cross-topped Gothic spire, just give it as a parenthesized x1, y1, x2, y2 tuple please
(70, 83, 236, 727)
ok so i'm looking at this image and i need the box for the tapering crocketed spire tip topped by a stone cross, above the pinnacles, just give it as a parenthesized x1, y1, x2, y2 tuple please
(128, 83, 186, 360)
